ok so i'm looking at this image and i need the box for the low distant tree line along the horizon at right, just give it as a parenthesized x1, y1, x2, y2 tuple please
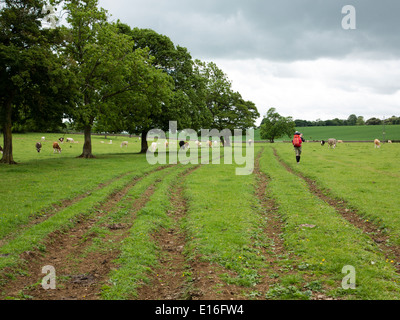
(294, 114, 400, 127)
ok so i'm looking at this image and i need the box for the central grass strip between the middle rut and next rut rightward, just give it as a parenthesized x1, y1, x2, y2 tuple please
(185, 160, 265, 286)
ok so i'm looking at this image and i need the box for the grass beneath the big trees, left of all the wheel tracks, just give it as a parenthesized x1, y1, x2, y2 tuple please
(0, 135, 159, 242)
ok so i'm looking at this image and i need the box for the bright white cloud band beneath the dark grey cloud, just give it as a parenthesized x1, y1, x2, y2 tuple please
(215, 59, 400, 123)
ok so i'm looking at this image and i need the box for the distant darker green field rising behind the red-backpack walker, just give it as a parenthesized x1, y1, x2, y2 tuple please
(255, 125, 400, 141)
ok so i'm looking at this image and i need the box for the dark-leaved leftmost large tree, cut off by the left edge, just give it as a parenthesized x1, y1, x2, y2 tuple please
(0, 0, 71, 164)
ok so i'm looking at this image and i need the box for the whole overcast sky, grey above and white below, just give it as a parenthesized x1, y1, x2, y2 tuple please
(99, 0, 400, 124)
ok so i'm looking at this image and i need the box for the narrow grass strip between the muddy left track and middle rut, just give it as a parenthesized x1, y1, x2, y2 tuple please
(102, 166, 191, 300)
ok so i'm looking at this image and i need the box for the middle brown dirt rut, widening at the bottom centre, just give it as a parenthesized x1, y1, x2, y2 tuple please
(138, 165, 241, 300)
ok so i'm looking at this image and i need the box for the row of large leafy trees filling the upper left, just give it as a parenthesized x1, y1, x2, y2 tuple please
(0, 0, 260, 164)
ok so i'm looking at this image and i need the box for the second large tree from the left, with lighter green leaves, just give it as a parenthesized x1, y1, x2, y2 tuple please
(60, 0, 166, 158)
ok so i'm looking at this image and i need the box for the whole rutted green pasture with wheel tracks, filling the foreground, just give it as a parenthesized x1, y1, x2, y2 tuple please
(0, 134, 400, 300)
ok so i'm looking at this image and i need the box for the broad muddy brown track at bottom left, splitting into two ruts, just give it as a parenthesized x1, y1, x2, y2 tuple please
(2, 166, 174, 300)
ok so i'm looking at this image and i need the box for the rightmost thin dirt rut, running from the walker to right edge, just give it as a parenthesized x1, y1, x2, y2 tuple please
(273, 148, 400, 273)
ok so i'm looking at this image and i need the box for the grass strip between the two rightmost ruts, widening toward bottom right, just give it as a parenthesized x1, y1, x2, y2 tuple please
(260, 145, 400, 300)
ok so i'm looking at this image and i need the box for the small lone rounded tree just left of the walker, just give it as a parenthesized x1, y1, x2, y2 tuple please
(260, 108, 295, 143)
